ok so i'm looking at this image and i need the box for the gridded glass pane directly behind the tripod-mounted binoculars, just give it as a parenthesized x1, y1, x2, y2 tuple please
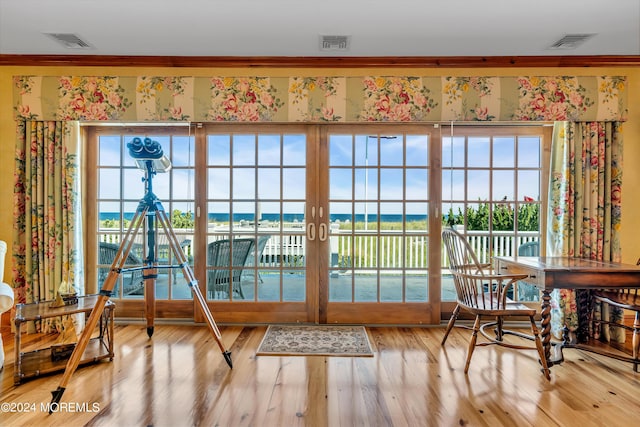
(96, 128, 195, 300)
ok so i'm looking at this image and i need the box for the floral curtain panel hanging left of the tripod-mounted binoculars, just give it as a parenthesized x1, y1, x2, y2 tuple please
(12, 120, 84, 332)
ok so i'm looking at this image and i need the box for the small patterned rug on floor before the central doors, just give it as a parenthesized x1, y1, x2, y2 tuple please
(256, 325, 373, 357)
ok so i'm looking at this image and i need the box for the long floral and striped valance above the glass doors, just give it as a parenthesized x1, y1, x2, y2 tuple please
(14, 76, 628, 122)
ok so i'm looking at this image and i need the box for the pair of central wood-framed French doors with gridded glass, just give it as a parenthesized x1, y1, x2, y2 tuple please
(194, 125, 440, 324)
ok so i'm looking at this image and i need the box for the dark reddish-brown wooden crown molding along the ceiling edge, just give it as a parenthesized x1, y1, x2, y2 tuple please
(0, 54, 640, 68)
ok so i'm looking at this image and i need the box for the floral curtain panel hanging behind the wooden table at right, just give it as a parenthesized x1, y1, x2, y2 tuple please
(547, 122, 624, 341)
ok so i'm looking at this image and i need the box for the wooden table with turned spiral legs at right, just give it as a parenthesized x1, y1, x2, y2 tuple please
(494, 256, 640, 366)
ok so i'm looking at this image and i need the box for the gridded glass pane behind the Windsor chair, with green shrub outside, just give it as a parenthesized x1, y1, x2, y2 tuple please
(441, 126, 548, 301)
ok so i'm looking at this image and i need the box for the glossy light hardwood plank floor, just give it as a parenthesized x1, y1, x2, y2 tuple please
(0, 324, 640, 427)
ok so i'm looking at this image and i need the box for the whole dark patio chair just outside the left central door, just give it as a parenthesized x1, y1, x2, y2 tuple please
(207, 238, 255, 299)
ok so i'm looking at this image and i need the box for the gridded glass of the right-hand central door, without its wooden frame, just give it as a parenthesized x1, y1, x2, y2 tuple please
(328, 129, 430, 322)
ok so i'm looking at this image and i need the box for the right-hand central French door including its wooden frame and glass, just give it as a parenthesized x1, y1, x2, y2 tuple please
(318, 126, 440, 324)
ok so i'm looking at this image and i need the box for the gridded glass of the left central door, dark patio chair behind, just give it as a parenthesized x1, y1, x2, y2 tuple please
(206, 130, 307, 302)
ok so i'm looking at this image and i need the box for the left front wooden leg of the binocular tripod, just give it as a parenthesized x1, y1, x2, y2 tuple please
(49, 208, 147, 414)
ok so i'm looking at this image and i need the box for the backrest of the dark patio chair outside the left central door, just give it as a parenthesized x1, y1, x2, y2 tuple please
(207, 238, 254, 285)
